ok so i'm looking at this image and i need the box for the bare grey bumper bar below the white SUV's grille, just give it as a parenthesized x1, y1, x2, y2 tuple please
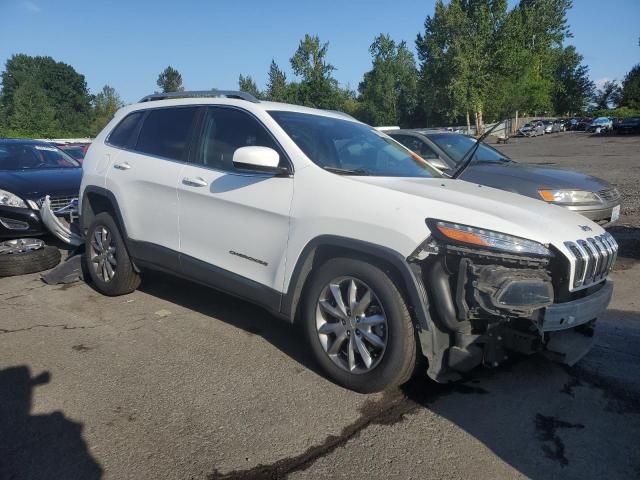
(542, 280, 613, 332)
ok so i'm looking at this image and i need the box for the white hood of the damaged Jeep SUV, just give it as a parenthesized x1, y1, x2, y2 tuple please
(350, 177, 604, 244)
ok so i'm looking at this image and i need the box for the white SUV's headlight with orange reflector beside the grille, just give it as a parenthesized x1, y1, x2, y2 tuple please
(430, 221, 551, 257)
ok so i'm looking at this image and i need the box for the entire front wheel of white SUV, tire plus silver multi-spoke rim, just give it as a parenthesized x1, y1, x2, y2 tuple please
(302, 258, 417, 393)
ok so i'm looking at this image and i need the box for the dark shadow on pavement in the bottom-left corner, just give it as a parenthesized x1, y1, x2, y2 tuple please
(0, 365, 102, 480)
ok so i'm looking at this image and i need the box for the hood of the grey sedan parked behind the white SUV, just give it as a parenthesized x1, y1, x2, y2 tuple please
(460, 162, 611, 199)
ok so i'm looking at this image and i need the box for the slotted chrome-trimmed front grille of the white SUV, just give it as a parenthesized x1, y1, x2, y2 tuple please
(564, 233, 618, 288)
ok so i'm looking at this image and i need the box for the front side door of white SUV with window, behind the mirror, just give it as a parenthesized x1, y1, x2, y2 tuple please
(178, 106, 293, 291)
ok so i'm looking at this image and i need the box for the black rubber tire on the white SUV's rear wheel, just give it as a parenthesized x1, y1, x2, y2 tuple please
(85, 212, 140, 296)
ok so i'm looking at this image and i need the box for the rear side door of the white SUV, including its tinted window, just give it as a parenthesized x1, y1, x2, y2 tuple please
(106, 106, 198, 269)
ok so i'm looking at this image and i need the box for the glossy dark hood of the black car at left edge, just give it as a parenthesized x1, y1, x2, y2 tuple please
(0, 168, 82, 200)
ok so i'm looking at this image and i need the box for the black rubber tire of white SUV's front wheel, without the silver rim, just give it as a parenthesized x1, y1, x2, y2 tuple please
(302, 258, 417, 393)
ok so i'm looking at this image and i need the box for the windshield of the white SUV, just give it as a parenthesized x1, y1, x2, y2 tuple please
(269, 111, 442, 178)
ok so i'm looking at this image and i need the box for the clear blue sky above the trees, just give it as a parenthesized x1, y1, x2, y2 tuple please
(0, 0, 640, 103)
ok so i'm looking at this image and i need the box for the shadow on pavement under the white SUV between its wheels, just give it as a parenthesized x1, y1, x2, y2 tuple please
(139, 271, 323, 375)
